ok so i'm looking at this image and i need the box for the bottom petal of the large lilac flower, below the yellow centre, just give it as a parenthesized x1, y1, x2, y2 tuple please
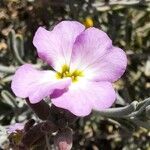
(52, 81, 116, 116)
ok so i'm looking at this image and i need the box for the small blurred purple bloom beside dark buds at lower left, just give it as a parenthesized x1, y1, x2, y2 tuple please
(7, 123, 24, 134)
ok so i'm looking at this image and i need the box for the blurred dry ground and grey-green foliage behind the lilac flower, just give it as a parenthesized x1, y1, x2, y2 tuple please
(0, 0, 150, 150)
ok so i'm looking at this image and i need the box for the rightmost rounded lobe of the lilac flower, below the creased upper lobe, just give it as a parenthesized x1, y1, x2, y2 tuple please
(84, 47, 127, 82)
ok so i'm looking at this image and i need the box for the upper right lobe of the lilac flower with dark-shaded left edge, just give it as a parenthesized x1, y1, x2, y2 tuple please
(71, 27, 112, 70)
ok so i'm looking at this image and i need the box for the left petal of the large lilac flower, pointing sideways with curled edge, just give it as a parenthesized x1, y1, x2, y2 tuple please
(11, 64, 71, 103)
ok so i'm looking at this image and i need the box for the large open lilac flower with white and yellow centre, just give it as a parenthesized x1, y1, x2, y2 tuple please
(11, 21, 127, 116)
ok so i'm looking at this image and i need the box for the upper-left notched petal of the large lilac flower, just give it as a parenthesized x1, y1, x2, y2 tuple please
(33, 21, 85, 71)
